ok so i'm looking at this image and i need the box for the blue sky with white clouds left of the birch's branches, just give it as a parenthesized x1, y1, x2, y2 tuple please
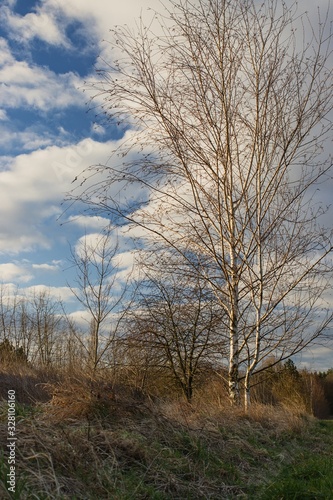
(0, 0, 333, 369)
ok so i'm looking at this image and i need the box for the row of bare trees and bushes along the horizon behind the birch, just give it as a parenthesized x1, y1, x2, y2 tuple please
(0, 270, 333, 418)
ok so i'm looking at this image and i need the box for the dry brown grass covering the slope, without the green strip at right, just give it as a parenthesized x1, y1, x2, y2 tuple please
(0, 366, 330, 500)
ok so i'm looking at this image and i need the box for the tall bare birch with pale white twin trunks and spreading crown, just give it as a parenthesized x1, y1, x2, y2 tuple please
(73, 0, 333, 405)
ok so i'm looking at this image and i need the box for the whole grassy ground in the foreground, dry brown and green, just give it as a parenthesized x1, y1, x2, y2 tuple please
(0, 374, 333, 500)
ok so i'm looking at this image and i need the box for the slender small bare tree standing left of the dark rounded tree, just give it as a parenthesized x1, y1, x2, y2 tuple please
(70, 227, 127, 374)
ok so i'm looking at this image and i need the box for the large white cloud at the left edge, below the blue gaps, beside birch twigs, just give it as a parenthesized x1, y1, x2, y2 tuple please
(0, 139, 141, 254)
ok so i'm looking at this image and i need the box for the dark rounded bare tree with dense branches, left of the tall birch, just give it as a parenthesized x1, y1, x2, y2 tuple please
(128, 252, 226, 401)
